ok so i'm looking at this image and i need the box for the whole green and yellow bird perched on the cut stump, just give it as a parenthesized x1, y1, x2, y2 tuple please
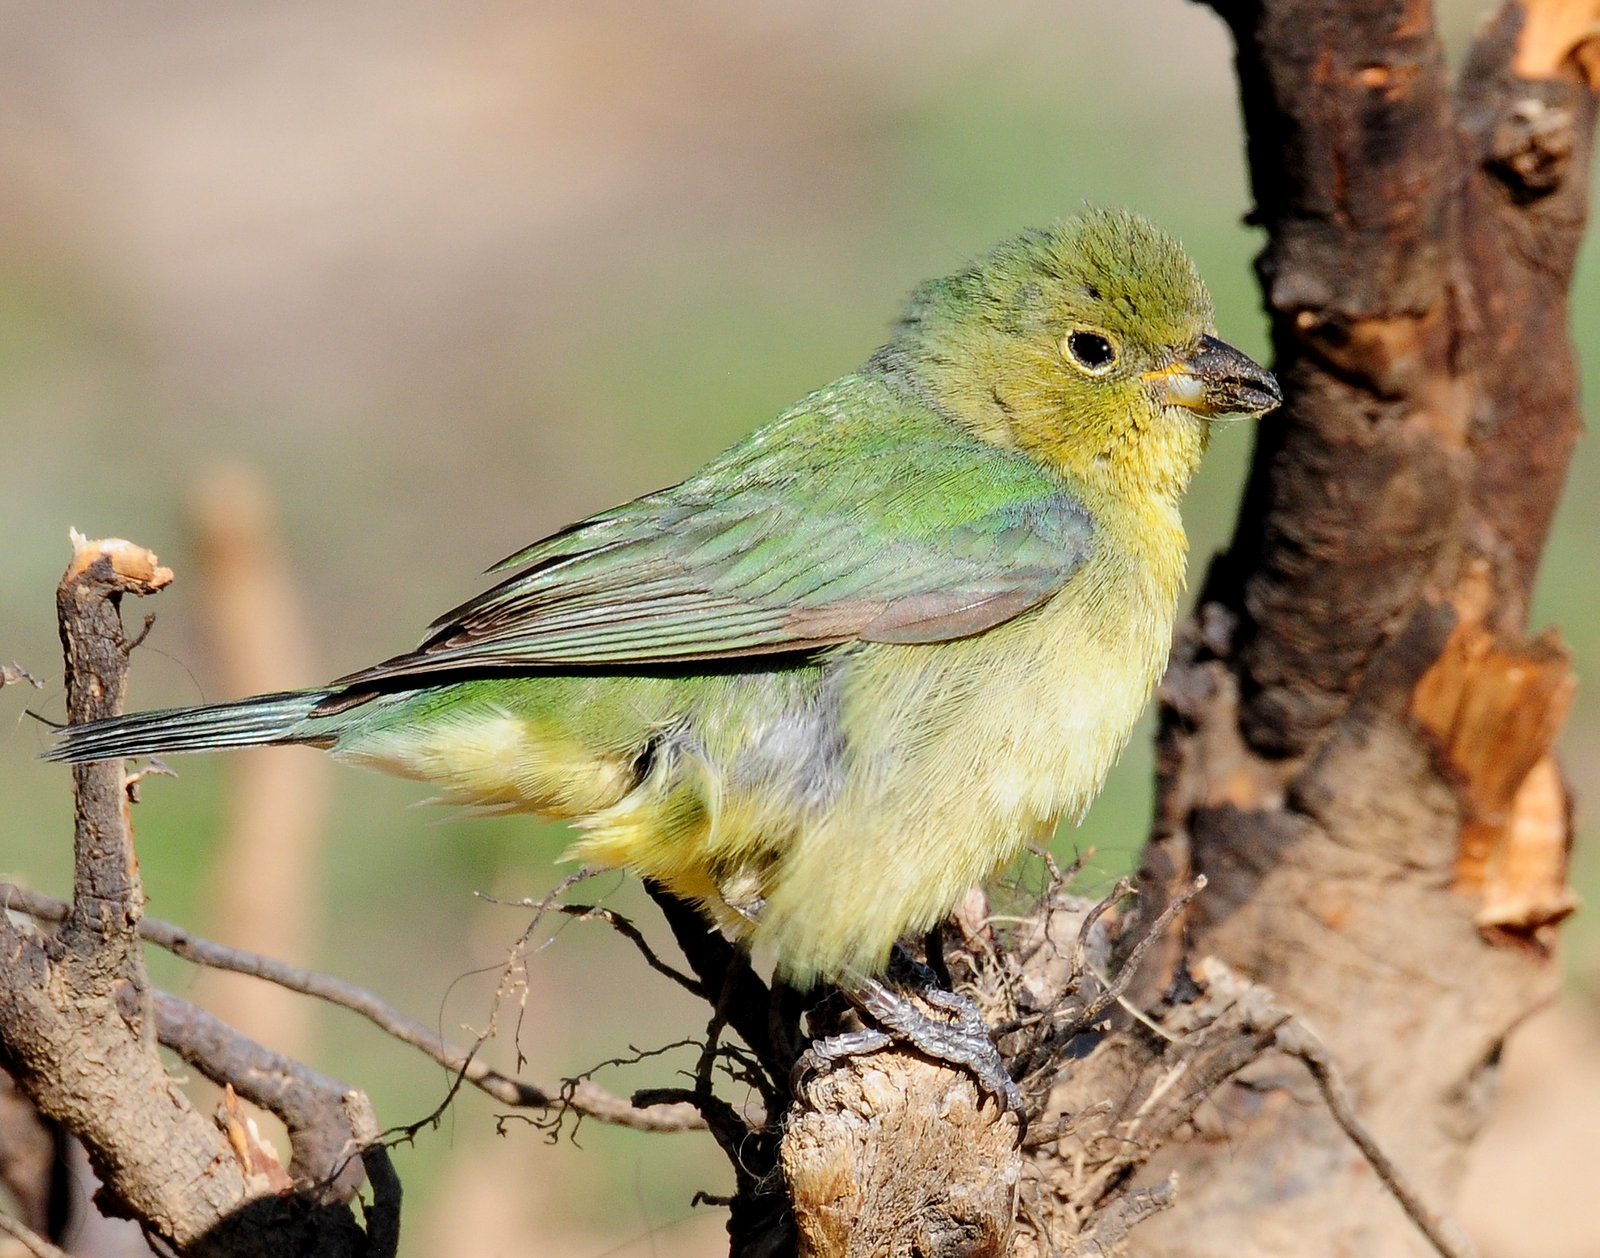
(48, 210, 1282, 1101)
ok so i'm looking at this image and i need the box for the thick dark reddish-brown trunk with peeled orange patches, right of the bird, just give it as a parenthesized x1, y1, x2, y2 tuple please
(1138, 0, 1597, 1258)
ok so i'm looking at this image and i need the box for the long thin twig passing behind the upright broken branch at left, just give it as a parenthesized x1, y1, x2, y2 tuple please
(0, 883, 706, 1132)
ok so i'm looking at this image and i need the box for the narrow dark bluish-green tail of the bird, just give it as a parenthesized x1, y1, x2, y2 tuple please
(43, 690, 328, 763)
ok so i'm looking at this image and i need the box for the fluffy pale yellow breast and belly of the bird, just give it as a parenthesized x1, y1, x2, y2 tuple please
(755, 550, 1174, 981)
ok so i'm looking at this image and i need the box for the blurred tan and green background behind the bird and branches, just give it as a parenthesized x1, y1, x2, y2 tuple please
(0, 0, 1600, 1258)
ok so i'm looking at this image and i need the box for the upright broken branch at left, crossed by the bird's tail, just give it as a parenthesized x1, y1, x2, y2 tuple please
(0, 536, 265, 1250)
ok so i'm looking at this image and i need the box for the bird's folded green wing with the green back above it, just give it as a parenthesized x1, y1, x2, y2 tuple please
(331, 378, 1094, 687)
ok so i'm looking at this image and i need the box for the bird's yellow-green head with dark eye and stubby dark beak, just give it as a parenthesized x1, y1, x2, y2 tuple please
(878, 210, 1283, 506)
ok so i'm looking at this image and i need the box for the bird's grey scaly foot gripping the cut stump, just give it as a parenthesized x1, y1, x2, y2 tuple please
(797, 944, 1027, 1127)
